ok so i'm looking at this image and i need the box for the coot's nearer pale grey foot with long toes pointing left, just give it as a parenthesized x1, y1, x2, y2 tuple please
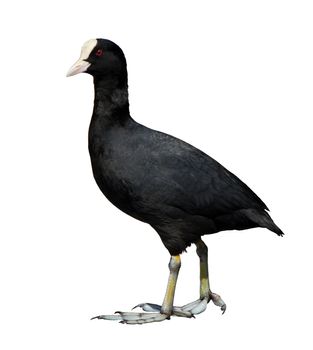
(92, 311, 170, 324)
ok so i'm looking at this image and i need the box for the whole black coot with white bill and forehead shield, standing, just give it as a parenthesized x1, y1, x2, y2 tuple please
(67, 39, 283, 324)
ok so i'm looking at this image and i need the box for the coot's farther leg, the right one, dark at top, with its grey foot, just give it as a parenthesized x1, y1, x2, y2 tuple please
(137, 239, 226, 317)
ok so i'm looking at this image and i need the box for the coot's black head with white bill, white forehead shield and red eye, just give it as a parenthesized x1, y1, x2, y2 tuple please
(67, 39, 127, 79)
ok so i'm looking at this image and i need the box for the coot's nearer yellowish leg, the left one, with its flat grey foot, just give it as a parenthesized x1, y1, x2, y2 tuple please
(92, 255, 193, 324)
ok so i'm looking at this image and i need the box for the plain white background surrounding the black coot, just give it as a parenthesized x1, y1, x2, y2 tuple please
(0, 0, 313, 350)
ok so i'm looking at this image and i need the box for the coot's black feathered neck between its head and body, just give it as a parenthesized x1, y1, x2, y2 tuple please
(93, 76, 130, 124)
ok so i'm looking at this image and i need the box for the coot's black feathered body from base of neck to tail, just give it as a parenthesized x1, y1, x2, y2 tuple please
(89, 84, 279, 255)
